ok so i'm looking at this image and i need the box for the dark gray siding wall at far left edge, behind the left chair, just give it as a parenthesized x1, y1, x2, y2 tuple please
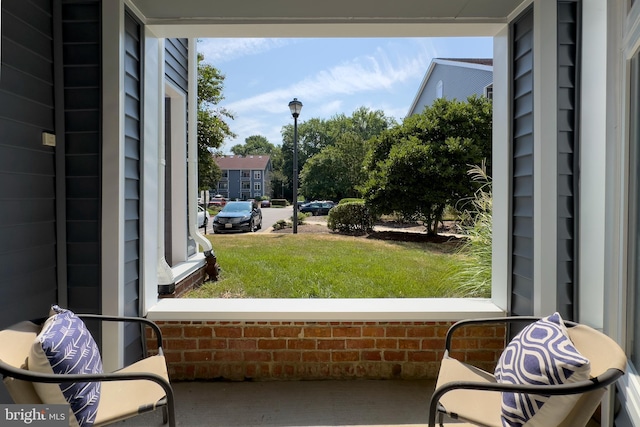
(0, 0, 57, 327)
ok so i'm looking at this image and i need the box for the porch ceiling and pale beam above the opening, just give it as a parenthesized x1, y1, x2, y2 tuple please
(129, 0, 528, 37)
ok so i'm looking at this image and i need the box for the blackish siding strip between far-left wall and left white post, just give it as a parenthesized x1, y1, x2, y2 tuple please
(59, 1, 102, 318)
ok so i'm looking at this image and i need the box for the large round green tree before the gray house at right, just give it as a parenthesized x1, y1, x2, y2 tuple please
(362, 97, 492, 234)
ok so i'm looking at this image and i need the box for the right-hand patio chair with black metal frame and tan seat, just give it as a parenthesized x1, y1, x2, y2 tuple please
(429, 317, 627, 427)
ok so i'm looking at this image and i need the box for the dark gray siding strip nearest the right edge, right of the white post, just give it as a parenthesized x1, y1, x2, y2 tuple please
(557, 1, 580, 319)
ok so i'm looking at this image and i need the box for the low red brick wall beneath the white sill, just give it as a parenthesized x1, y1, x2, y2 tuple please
(147, 321, 505, 381)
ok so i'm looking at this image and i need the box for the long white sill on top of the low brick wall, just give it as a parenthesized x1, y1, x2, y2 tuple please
(147, 298, 506, 322)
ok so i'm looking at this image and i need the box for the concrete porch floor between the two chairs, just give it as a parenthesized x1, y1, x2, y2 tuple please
(118, 380, 435, 427)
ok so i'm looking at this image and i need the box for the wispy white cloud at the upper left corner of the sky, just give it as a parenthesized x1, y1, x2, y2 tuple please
(198, 38, 292, 66)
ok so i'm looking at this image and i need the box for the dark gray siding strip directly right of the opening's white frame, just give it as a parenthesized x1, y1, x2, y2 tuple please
(510, 9, 534, 315)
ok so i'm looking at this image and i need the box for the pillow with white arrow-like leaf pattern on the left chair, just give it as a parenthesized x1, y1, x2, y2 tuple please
(28, 306, 103, 427)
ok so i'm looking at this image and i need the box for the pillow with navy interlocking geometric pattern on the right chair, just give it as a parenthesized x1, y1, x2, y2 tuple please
(495, 313, 591, 427)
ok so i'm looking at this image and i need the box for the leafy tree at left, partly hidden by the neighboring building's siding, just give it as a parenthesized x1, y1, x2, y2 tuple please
(197, 53, 235, 190)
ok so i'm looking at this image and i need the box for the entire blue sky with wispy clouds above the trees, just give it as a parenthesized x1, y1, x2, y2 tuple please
(198, 37, 493, 153)
